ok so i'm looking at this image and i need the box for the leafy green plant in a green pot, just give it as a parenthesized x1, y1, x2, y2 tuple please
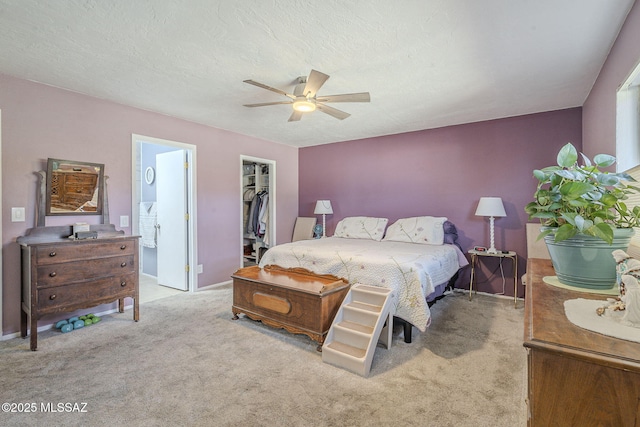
(525, 143, 640, 290)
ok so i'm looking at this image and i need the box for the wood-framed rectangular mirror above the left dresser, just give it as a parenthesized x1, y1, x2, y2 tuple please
(46, 159, 104, 215)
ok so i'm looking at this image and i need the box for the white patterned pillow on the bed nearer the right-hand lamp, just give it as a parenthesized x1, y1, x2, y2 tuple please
(383, 216, 447, 245)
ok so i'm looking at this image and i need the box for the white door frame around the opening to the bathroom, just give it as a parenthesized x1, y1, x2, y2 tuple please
(131, 134, 198, 292)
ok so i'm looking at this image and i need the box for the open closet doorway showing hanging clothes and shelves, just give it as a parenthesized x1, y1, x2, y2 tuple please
(240, 156, 276, 267)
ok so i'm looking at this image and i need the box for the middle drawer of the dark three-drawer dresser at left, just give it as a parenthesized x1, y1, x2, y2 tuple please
(36, 255, 136, 288)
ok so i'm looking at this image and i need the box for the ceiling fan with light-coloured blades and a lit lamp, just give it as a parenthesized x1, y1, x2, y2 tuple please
(244, 70, 371, 122)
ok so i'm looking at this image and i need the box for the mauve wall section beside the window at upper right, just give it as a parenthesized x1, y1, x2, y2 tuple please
(582, 2, 640, 155)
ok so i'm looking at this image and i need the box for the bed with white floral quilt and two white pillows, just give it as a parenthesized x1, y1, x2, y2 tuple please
(259, 216, 468, 342)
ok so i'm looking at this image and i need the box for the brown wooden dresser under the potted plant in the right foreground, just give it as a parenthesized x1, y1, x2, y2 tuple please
(524, 259, 640, 427)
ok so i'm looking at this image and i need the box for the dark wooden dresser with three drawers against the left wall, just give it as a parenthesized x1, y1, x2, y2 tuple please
(17, 225, 139, 350)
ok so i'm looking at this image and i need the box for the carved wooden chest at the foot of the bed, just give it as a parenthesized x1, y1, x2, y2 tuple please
(231, 266, 349, 351)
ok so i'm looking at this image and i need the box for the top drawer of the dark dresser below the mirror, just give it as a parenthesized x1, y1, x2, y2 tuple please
(35, 239, 135, 265)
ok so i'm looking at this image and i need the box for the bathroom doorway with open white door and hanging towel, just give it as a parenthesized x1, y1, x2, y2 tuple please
(132, 134, 197, 302)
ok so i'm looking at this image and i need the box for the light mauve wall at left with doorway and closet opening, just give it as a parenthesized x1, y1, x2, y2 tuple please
(0, 75, 298, 334)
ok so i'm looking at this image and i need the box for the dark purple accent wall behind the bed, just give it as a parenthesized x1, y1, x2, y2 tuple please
(299, 108, 582, 295)
